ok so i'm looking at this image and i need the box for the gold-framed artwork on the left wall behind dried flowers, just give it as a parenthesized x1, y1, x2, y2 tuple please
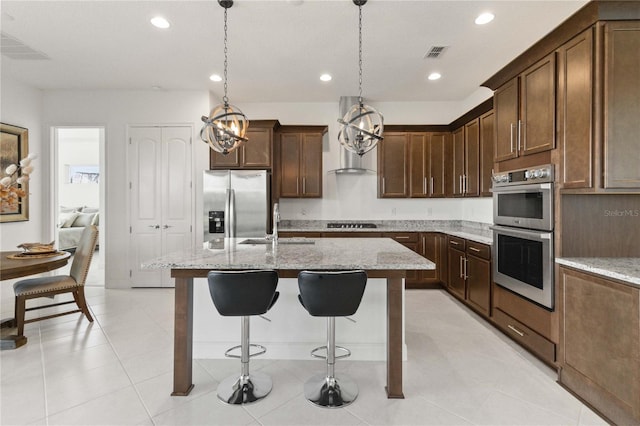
(0, 123, 29, 223)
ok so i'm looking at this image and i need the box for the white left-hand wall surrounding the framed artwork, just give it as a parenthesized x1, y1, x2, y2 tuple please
(0, 70, 45, 250)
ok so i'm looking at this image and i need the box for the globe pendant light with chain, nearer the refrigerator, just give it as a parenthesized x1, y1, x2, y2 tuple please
(200, 0, 249, 155)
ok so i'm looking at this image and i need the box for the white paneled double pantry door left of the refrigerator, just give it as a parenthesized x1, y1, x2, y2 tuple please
(129, 127, 193, 287)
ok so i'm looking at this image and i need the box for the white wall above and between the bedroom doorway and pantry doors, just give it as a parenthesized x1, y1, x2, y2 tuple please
(42, 90, 209, 288)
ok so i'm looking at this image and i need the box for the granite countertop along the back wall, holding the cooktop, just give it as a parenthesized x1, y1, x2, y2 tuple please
(279, 220, 493, 245)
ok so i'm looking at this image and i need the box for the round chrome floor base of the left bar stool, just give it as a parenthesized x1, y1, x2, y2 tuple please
(218, 372, 273, 405)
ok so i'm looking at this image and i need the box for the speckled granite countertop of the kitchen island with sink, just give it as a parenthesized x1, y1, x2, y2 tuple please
(142, 238, 435, 271)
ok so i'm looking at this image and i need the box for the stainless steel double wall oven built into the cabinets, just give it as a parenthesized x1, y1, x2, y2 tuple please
(491, 165, 554, 310)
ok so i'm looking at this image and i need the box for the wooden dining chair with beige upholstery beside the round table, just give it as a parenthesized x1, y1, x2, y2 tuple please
(13, 225, 98, 336)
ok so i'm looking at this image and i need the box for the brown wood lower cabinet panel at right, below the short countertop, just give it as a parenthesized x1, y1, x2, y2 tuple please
(559, 267, 640, 425)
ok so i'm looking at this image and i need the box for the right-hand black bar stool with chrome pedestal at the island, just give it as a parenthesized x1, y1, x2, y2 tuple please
(298, 271, 367, 408)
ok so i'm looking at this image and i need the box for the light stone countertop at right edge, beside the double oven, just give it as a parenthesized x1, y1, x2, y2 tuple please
(556, 257, 640, 287)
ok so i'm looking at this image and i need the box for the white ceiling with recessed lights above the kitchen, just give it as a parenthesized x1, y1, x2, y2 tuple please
(1, 0, 587, 104)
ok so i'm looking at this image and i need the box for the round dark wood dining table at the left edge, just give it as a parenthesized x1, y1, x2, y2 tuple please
(0, 250, 71, 349)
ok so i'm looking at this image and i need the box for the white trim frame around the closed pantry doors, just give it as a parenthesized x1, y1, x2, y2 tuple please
(125, 122, 196, 288)
